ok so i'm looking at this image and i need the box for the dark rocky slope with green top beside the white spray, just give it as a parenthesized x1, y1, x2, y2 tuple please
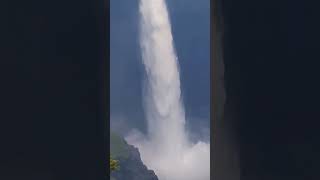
(110, 133, 158, 180)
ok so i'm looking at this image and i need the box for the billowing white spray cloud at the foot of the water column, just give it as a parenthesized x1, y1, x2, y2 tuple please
(126, 130, 210, 180)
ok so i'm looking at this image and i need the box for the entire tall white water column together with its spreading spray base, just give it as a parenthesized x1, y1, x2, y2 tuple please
(126, 0, 210, 180)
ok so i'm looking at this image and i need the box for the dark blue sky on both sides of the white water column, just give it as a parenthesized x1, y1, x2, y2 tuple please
(110, 0, 210, 139)
